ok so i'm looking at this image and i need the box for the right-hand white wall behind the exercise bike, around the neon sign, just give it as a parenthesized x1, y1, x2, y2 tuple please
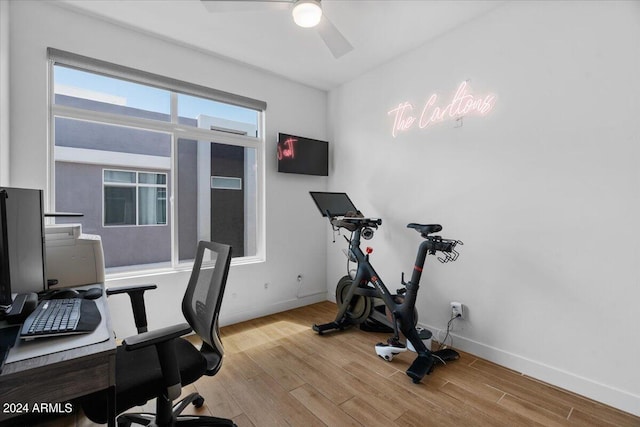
(327, 1, 640, 415)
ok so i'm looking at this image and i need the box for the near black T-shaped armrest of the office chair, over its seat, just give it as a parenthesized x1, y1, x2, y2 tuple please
(122, 323, 191, 400)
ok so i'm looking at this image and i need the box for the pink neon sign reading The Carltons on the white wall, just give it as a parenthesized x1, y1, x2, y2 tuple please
(387, 81, 496, 138)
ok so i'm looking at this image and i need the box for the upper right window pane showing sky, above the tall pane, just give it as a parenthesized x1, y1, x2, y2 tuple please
(178, 94, 259, 137)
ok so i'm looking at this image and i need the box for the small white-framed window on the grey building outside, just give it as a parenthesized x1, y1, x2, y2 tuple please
(103, 170, 167, 227)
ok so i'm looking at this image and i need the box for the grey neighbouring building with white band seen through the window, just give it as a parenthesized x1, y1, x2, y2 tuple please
(54, 94, 257, 268)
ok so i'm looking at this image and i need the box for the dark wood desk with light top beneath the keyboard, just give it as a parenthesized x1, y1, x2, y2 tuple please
(0, 285, 116, 426)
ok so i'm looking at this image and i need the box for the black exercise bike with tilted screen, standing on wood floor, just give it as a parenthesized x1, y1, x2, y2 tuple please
(311, 192, 462, 383)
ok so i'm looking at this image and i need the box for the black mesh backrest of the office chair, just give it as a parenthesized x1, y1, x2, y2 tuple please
(182, 241, 231, 375)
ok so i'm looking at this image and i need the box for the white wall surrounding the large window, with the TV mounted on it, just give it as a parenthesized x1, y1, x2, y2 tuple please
(10, 2, 327, 337)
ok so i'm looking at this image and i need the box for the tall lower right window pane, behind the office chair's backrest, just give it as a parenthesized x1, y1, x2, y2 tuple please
(177, 139, 258, 261)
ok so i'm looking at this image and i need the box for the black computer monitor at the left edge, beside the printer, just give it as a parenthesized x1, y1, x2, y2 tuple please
(0, 187, 47, 299)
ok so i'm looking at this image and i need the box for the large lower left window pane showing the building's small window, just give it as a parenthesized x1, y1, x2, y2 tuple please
(54, 117, 171, 273)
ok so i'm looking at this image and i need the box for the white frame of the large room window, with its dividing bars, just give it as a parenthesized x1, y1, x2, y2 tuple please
(47, 48, 267, 278)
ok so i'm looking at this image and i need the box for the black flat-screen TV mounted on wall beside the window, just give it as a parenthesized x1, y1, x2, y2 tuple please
(278, 133, 329, 176)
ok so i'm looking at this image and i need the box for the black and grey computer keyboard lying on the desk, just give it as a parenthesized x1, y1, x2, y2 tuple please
(20, 298, 102, 340)
